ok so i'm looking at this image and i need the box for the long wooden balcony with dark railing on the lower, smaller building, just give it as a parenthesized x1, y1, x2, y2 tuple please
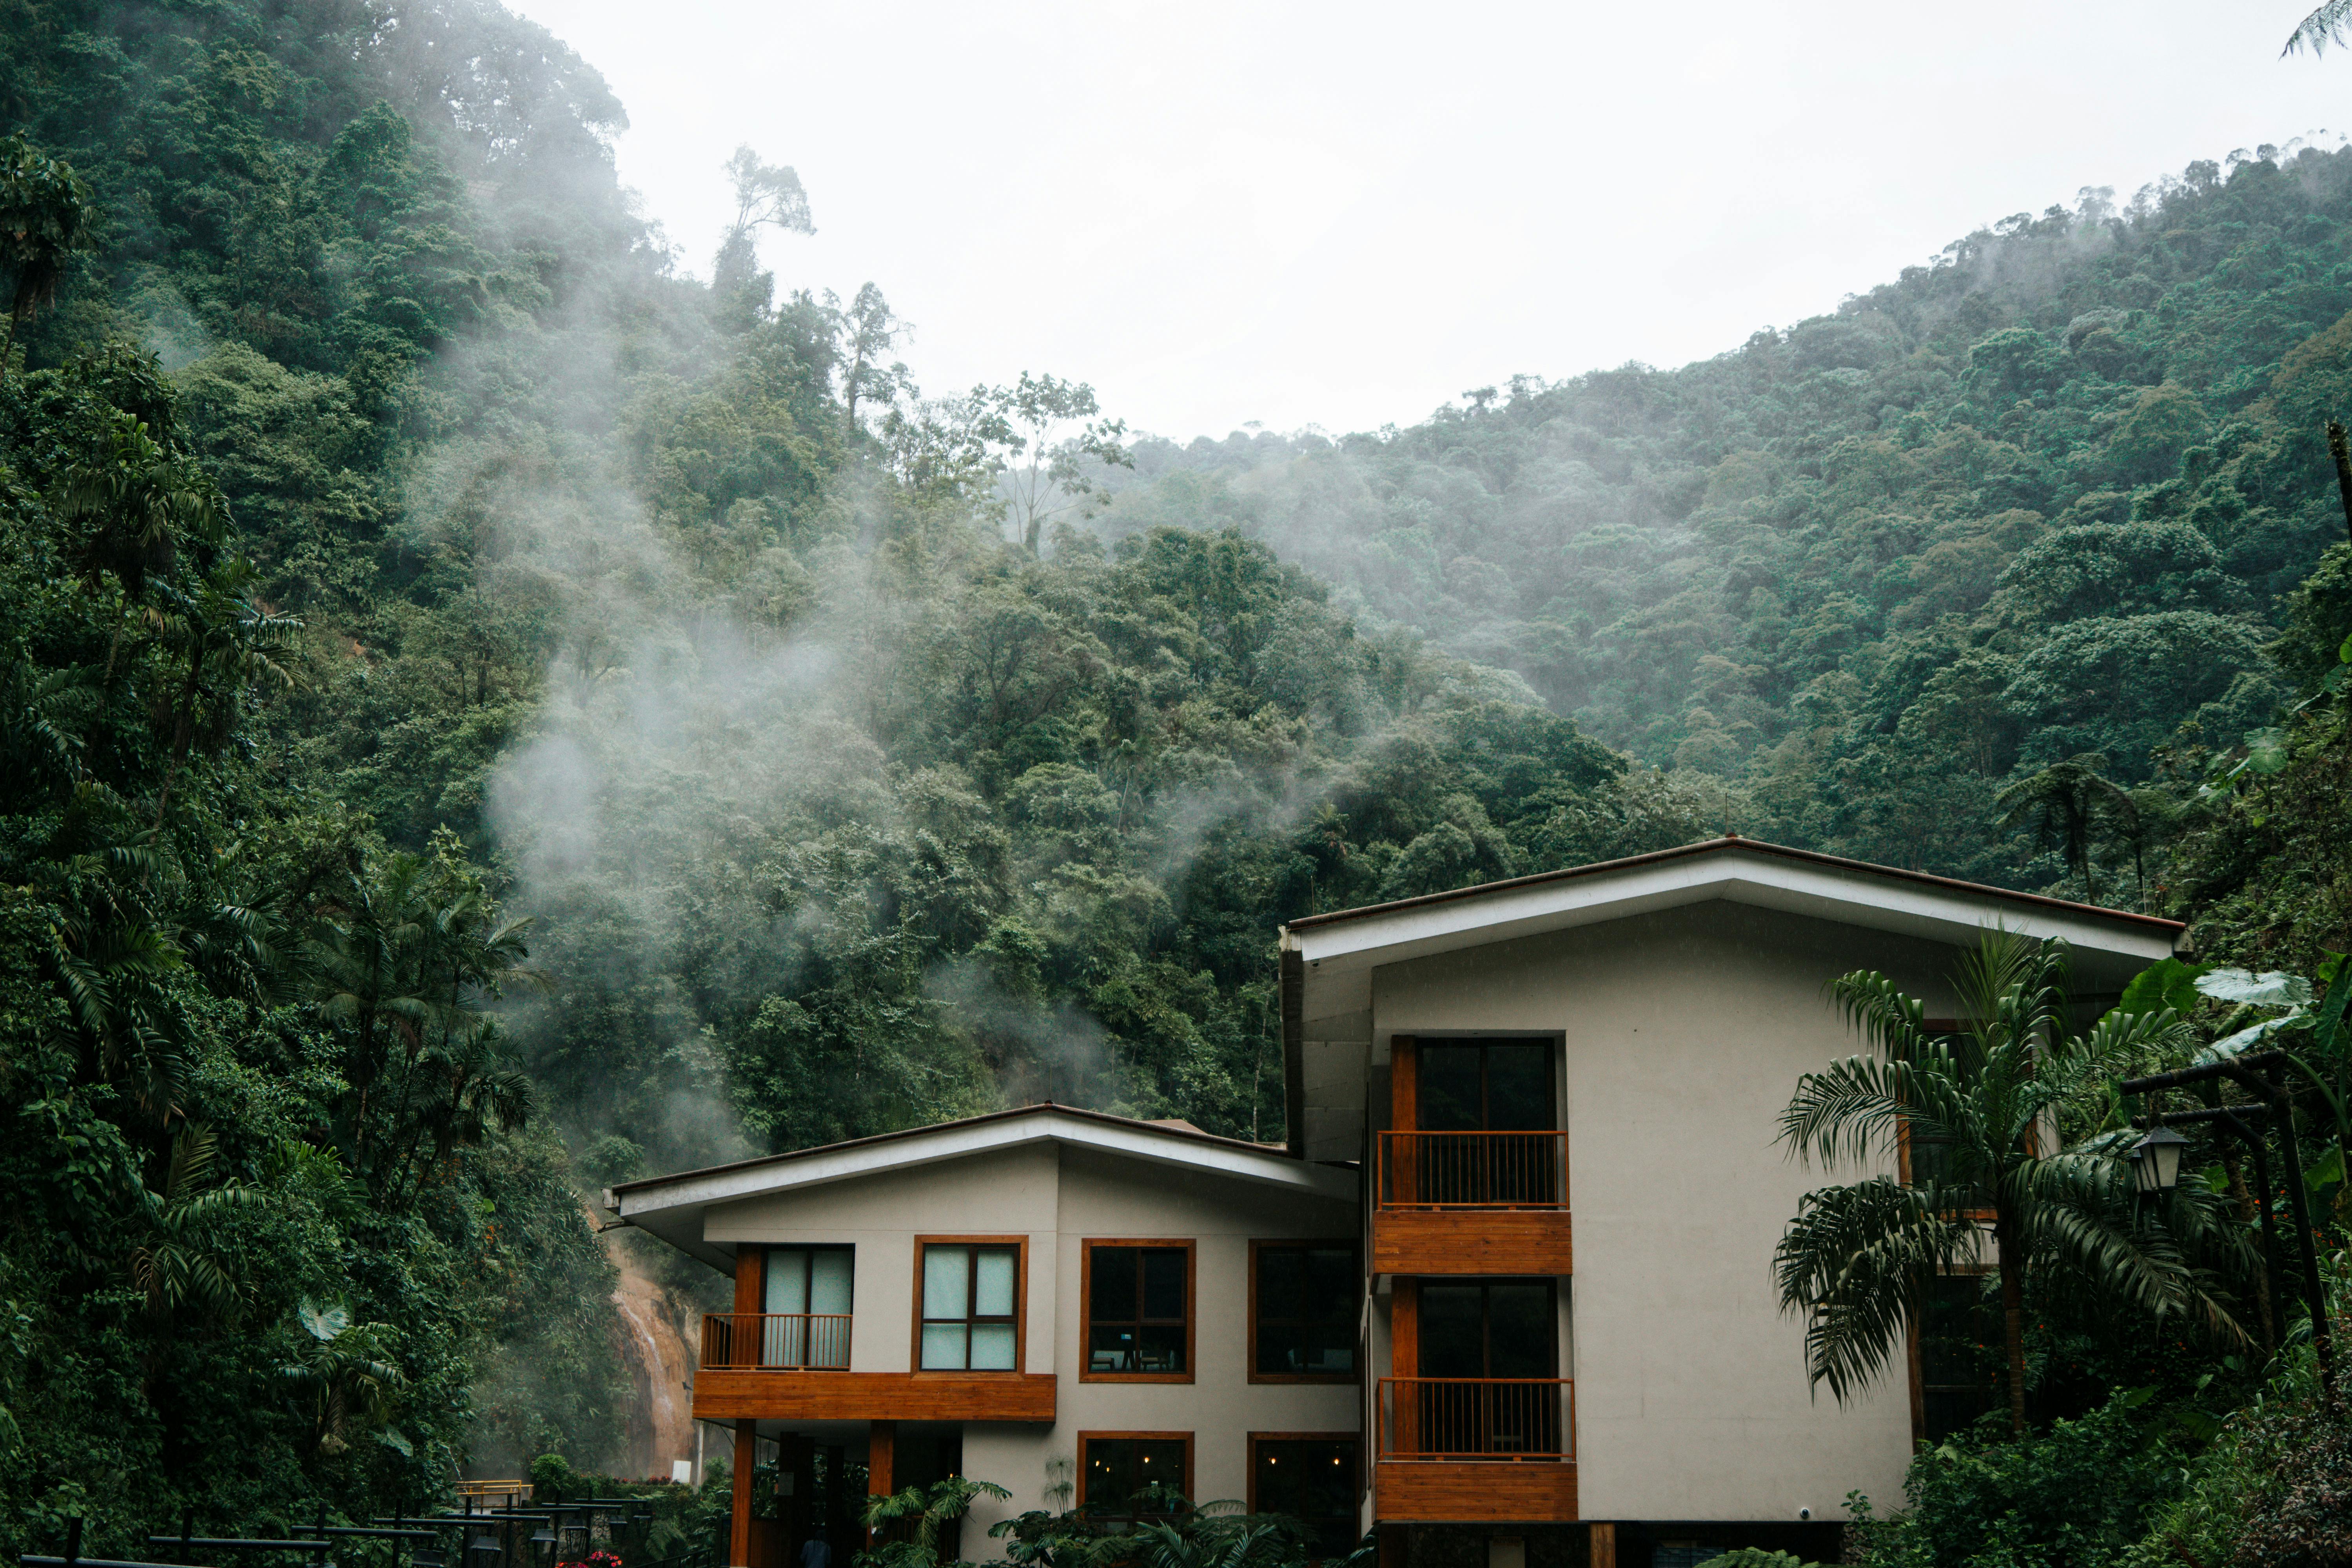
(694, 1312, 1056, 1422)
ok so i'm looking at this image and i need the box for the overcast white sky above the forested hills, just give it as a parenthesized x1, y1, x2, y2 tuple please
(508, 0, 2352, 437)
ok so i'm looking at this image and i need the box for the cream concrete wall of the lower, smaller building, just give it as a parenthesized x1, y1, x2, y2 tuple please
(703, 1145, 1357, 1556)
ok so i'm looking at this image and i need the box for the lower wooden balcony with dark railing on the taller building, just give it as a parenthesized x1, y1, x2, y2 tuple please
(1374, 1377, 1576, 1523)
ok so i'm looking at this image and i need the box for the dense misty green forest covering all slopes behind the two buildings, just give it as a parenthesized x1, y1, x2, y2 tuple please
(0, 0, 2352, 1561)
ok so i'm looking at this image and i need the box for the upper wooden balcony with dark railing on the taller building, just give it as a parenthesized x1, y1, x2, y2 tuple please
(1371, 1131, 1573, 1274)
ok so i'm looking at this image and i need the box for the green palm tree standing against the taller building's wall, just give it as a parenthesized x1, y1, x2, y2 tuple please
(1773, 931, 2251, 1432)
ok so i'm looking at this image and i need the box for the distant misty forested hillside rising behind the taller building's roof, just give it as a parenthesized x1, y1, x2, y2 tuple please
(1103, 148, 2352, 898)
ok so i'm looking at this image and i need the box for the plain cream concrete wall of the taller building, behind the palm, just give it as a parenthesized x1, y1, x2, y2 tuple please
(1371, 900, 1957, 1521)
